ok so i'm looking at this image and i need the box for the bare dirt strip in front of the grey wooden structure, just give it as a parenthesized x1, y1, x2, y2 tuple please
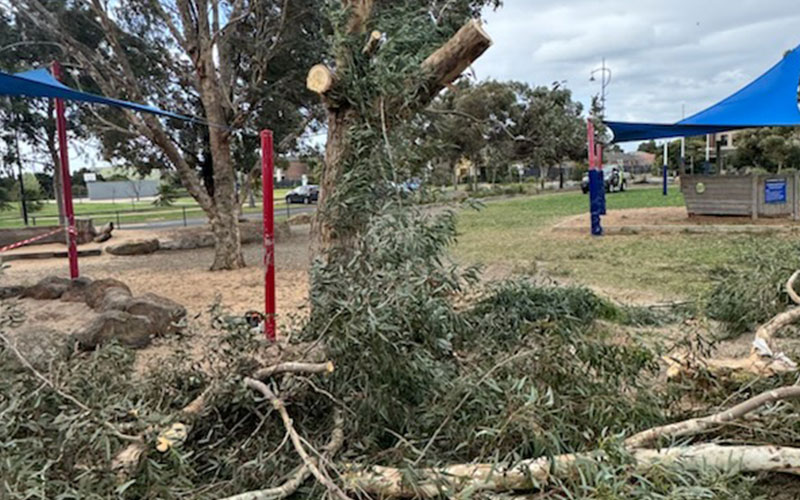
(558, 207, 800, 230)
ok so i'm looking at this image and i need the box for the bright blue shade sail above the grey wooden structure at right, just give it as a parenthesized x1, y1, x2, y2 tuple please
(604, 47, 800, 142)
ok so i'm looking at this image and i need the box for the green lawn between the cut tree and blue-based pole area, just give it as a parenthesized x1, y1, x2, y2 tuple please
(454, 188, 780, 298)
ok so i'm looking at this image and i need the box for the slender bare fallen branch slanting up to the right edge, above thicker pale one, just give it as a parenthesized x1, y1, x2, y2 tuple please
(625, 386, 800, 448)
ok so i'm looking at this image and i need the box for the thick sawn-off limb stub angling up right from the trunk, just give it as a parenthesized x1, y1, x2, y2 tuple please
(422, 19, 492, 98)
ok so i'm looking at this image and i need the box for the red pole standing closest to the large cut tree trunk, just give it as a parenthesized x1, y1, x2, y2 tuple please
(261, 130, 275, 342)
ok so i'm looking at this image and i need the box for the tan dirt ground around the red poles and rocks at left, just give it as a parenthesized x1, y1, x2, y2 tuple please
(0, 226, 309, 374)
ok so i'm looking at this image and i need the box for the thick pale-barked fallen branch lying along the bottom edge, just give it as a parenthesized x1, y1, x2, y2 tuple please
(344, 444, 800, 498)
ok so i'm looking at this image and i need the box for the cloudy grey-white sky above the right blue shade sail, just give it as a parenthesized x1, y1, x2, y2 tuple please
(474, 0, 800, 134)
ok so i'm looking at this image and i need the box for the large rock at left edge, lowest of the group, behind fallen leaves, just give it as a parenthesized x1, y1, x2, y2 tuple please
(3, 326, 69, 371)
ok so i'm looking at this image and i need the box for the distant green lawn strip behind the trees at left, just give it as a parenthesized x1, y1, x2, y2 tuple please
(0, 189, 289, 228)
